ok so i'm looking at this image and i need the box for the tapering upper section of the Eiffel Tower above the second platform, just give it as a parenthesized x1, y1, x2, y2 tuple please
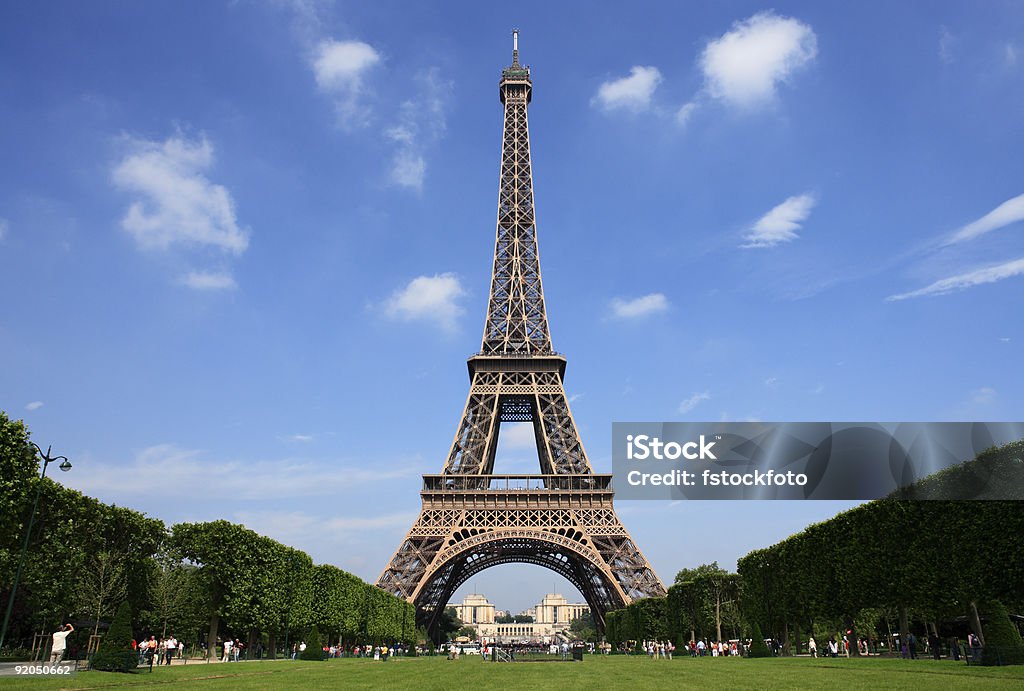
(480, 30, 551, 355)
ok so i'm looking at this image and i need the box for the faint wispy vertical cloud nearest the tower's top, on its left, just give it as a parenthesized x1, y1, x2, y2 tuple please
(384, 68, 454, 191)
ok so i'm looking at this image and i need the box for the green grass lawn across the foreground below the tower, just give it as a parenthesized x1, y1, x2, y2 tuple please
(0, 655, 1024, 690)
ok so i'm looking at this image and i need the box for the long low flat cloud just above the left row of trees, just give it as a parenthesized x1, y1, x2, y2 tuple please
(67, 444, 422, 504)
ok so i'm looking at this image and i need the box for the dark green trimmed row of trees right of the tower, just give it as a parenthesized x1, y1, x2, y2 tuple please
(605, 442, 1024, 661)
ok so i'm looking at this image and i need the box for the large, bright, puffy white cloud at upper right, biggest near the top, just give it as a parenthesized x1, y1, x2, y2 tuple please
(700, 12, 817, 107)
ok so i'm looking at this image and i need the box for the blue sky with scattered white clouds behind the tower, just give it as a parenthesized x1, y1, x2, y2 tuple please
(0, 1, 1024, 610)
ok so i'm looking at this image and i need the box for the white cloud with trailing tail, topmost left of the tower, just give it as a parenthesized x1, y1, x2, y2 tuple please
(312, 40, 381, 129)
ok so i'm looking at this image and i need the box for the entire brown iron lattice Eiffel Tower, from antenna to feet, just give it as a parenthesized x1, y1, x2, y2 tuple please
(377, 31, 666, 637)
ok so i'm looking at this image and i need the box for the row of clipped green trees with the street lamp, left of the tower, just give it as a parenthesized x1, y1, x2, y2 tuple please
(0, 412, 417, 654)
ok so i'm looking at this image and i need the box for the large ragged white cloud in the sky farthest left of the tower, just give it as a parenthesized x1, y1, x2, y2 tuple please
(113, 135, 249, 254)
